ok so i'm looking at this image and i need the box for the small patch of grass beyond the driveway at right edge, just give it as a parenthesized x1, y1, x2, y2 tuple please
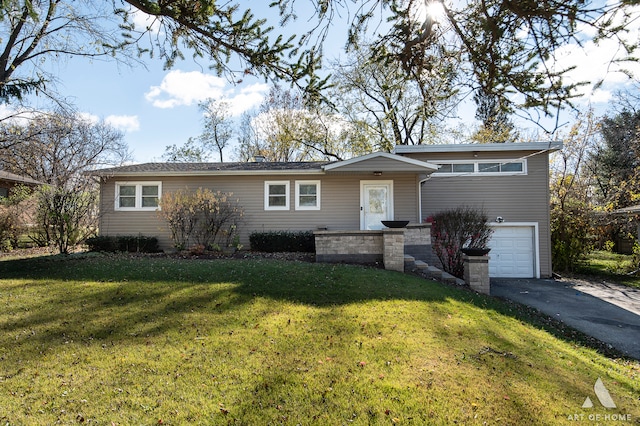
(577, 250, 640, 288)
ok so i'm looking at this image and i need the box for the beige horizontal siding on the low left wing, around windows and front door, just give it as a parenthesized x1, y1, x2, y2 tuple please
(100, 173, 418, 248)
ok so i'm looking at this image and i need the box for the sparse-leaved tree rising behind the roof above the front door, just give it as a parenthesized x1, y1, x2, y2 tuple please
(331, 41, 460, 151)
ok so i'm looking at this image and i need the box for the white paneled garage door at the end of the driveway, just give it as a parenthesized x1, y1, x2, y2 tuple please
(489, 226, 536, 278)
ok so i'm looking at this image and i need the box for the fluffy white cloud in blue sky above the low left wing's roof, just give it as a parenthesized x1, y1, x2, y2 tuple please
(145, 70, 269, 116)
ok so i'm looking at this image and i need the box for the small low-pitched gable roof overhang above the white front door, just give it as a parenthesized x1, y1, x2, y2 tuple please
(323, 152, 438, 173)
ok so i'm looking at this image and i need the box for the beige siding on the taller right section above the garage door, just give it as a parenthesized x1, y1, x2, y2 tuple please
(411, 151, 552, 277)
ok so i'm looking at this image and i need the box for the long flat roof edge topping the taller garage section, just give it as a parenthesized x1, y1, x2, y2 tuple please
(393, 141, 563, 154)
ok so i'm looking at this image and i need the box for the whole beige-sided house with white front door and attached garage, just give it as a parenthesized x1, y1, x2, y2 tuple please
(94, 143, 562, 277)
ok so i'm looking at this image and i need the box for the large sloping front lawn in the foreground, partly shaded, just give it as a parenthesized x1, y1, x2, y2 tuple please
(0, 254, 640, 425)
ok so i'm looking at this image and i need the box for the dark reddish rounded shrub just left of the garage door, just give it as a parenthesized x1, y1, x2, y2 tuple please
(431, 207, 493, 278)
